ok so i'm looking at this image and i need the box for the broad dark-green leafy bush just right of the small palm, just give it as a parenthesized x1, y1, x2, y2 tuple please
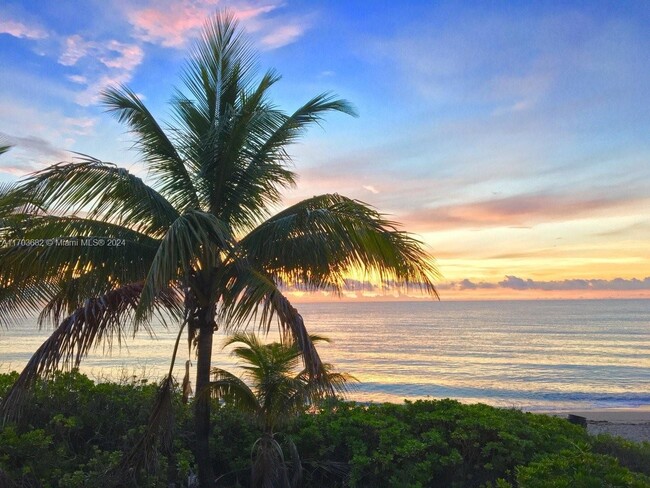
(290, 400, 588, 487)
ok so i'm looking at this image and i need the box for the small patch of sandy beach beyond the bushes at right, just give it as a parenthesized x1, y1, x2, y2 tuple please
(549, 405, 650, 442)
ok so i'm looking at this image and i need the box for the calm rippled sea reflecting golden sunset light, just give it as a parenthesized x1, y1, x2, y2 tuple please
(0, 300, 650, 410)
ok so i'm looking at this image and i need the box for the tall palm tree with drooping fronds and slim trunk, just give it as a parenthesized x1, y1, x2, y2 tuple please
(0, 14, 436, 487)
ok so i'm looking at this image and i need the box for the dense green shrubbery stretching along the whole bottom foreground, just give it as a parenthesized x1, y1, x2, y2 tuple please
(0, 373, 650, 488)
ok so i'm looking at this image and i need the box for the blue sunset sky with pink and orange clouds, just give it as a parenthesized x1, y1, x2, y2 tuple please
(0, 0, 650, 300)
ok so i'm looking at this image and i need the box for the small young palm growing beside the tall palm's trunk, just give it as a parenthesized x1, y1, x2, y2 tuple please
(210, 333, 346, 487)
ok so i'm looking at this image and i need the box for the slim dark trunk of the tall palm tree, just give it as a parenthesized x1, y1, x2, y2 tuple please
(194, 307, 216, 488)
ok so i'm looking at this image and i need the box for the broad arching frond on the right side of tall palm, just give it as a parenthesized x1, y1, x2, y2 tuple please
(239, 194, 438, 296)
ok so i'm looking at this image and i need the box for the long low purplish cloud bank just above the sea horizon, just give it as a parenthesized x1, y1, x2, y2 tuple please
(438, 275, 650, 291)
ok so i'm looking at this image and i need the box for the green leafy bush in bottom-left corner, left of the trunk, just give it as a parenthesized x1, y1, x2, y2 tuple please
(0, 371, 177, 487)
